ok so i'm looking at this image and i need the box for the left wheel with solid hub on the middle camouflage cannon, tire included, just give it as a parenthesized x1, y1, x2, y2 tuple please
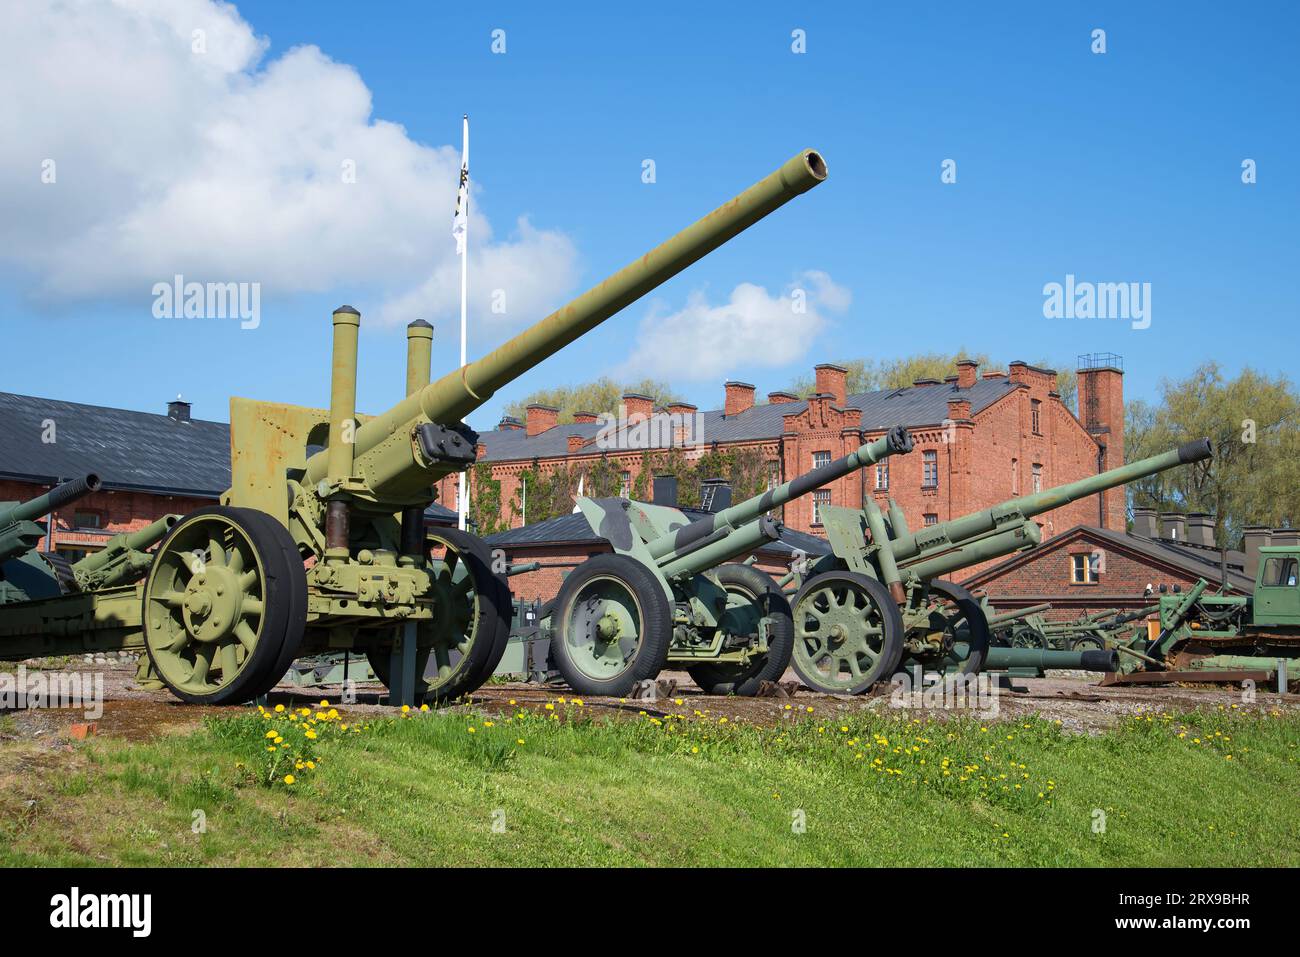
(551, 554, 672, 696)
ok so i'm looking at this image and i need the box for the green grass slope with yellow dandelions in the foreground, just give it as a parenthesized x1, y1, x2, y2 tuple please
(0, 705, 1300, 866)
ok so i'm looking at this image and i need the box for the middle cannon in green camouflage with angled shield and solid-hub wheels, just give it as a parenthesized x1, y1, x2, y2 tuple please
(549, 428, 911, 696)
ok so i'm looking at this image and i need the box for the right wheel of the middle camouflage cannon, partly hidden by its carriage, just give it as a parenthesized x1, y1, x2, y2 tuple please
(686, 564, 794, 696)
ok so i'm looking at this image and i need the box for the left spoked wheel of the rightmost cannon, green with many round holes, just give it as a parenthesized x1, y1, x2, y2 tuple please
(790, 571, 902, 694)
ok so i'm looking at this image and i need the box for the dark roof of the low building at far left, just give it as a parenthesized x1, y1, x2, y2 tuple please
(0, 393, 230, 498)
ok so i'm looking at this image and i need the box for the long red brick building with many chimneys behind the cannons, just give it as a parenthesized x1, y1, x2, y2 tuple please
(439, 356, 1126, 548)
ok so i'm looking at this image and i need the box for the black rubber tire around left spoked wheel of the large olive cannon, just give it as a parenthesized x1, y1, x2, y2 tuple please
(140, 505, 306, 705)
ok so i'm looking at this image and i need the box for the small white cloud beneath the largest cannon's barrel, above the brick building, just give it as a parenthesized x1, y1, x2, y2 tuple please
(619, 270, 853, 381)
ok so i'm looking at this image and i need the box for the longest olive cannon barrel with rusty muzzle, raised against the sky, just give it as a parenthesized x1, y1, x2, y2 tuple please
(306, 150, 827, 486)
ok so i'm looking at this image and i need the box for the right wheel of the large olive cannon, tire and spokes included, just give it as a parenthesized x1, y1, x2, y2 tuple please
(367, 528, 514, 703)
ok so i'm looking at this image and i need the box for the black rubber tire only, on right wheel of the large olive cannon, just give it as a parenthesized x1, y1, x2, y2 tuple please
(365, 528, 515, 705)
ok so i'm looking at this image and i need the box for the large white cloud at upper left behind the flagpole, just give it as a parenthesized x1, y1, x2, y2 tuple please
(0, 0, 577, 328)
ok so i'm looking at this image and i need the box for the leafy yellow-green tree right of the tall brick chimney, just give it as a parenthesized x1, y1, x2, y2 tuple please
(1125, 361, 1300, 545)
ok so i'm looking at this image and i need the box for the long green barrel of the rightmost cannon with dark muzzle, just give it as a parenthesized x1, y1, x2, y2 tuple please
(891, 438, 1213, 562)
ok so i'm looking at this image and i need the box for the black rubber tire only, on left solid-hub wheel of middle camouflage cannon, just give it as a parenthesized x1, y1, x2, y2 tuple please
(551, 554, 672, 697)
